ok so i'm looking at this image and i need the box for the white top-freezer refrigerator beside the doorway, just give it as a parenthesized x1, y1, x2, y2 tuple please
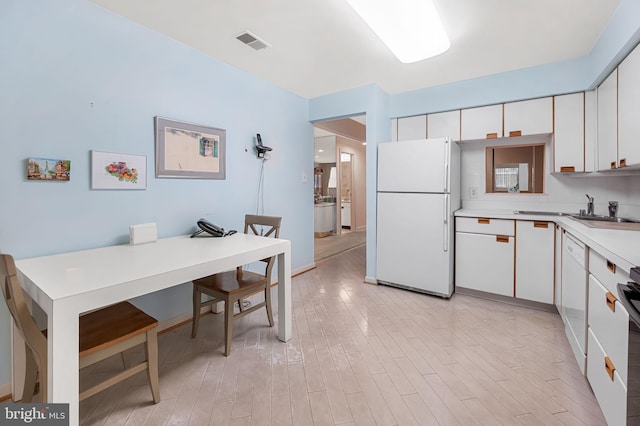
(376, 138, 460, 298)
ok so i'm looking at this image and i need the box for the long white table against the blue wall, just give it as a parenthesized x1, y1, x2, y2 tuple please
(16, 233, 291, 425)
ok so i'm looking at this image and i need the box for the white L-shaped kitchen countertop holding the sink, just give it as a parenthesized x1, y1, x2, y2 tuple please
(455, 209, 640, 273)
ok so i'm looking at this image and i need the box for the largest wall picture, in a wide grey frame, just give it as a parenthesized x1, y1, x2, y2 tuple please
(155, 117, 226, 179)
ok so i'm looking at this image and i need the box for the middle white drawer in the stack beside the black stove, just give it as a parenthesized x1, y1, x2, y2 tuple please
(588, 275, 629, 385)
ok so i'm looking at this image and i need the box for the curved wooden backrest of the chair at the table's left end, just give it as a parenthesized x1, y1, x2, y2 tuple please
(0, 254, 47, 372)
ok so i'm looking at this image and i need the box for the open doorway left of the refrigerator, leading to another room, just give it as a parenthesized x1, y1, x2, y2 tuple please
(313, 115, 366, 262)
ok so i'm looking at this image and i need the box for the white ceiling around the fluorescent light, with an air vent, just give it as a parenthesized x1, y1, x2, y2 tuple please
(91, 0, 619, 98)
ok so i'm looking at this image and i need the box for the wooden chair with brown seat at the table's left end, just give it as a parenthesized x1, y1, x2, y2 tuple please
(0, 254, 160, 403)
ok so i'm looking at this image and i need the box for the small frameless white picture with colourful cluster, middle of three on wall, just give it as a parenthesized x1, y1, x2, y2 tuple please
(91, 151, 147, 189)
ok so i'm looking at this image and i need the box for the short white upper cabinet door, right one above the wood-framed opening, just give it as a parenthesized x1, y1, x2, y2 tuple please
(504, 97, 553, 137)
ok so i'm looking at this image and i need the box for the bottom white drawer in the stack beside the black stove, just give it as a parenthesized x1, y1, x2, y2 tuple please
(587, 328, 627, 426)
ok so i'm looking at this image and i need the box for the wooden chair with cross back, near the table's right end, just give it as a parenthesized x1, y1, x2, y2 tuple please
(191, 214, 282, 356)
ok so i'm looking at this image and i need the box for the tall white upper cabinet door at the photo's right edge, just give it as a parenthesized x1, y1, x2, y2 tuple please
(618, 43, 640, 167)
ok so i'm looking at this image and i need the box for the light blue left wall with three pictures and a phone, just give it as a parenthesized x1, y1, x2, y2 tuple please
(0, 0, 313, 384)
